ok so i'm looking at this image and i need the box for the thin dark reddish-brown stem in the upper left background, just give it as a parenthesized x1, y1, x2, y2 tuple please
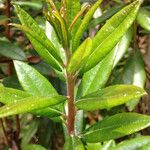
(5, 0, 11, 39)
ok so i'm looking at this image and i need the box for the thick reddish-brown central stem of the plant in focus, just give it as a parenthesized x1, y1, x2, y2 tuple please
(67, 74, 76, 135)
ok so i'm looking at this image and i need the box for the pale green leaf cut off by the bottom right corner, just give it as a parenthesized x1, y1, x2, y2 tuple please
(111, 136, 150, 150)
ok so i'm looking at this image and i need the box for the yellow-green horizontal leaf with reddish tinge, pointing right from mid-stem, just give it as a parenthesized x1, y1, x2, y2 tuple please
(75, 85, 146, 111)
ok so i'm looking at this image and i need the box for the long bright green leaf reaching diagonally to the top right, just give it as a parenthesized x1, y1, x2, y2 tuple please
(82, 0, 141, 72)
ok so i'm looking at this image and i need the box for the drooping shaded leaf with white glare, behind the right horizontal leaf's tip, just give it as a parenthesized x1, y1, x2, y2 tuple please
(115, 50, 146, 111)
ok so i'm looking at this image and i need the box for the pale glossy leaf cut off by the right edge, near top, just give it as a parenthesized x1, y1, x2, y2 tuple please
(137, 8, 150, 31)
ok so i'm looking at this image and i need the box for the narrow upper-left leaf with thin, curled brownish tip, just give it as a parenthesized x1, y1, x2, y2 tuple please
(11, 24, 62, 71)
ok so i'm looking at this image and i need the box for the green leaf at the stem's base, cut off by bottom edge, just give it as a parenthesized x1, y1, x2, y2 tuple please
(63, 137, 85, 150)
